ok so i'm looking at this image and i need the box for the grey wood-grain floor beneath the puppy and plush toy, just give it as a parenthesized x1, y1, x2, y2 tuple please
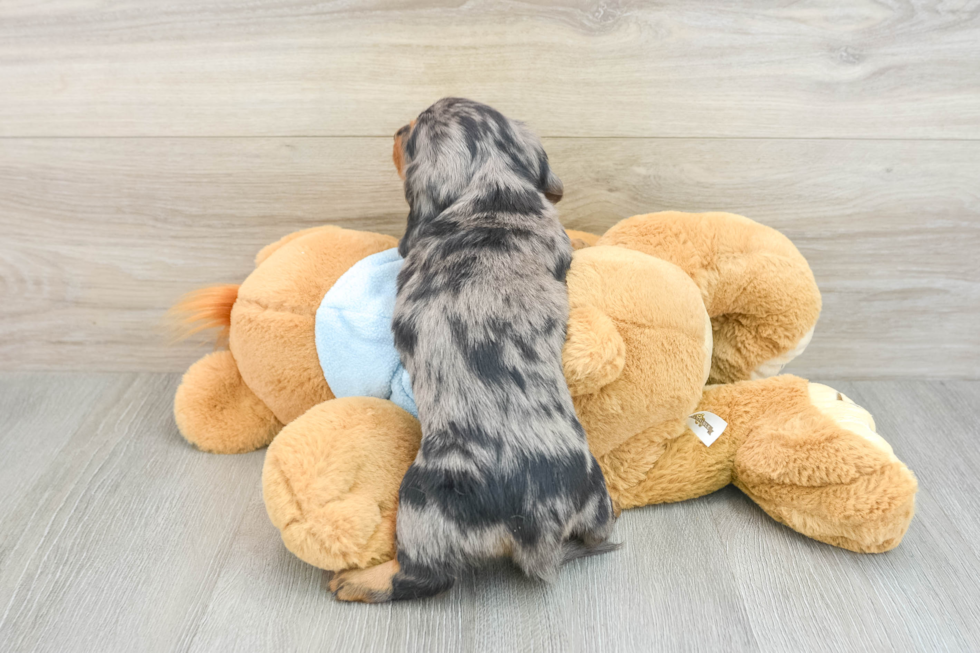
(0, 373, 980, 653)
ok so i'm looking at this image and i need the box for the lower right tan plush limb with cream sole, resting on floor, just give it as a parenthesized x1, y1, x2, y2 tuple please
(699, 375, 917, 553)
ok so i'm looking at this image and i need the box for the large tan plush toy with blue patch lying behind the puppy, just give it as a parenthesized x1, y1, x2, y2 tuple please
(174, 212, 916, 570)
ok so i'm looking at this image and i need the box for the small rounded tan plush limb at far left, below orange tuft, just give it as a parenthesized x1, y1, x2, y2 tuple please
(174, 351, 282, 453)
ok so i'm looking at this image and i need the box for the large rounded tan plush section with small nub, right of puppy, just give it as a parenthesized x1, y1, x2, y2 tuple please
(563, 246, 712, 458)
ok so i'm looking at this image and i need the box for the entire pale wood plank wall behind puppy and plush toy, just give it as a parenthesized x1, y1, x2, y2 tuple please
(0, 0, 980, 378)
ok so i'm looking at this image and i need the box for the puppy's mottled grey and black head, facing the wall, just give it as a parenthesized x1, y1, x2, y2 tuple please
(393, 98, 563, 256)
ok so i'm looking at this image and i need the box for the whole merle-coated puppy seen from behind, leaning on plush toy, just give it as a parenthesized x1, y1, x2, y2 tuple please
(331, 98, 615, 602)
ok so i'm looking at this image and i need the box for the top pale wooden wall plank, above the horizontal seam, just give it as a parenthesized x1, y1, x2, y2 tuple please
(0, 0, 980, 139)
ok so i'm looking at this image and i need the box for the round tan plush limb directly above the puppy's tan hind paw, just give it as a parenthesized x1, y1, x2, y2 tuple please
(262, 397, 422, 571)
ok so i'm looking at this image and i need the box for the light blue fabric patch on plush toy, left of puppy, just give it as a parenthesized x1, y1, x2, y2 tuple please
(315, 249, 418, 417)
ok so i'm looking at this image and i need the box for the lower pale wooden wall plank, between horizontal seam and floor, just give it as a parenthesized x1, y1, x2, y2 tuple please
(0, 138, 980, 378)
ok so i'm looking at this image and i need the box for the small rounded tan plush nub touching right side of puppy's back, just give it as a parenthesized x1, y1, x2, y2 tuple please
(562, 306, 626, 397)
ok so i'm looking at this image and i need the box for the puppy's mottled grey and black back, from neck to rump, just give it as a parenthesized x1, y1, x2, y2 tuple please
(394, 195, 612, 577)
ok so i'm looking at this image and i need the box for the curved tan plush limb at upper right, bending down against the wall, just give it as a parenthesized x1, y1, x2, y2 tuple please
(598, 211, 821, 383)
